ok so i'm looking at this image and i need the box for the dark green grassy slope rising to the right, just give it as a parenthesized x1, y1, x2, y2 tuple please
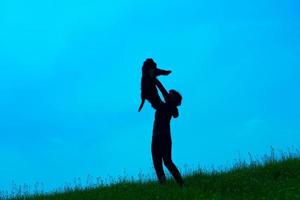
(7, 152, 300, 200)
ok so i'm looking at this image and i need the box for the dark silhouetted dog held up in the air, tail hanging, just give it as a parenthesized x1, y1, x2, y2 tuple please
(139, 58, 171, 112)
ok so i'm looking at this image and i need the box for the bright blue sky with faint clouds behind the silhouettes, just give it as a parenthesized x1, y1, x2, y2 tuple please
(0, 0, 300, 192)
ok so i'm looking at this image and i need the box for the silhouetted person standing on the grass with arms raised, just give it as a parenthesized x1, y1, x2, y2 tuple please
(151, 79, 183, 186)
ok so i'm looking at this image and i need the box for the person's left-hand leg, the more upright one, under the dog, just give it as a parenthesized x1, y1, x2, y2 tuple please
(151, 136, 166, 183)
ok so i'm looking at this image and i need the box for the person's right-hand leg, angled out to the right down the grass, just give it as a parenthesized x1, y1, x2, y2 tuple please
(163, 136, 183, 186)
